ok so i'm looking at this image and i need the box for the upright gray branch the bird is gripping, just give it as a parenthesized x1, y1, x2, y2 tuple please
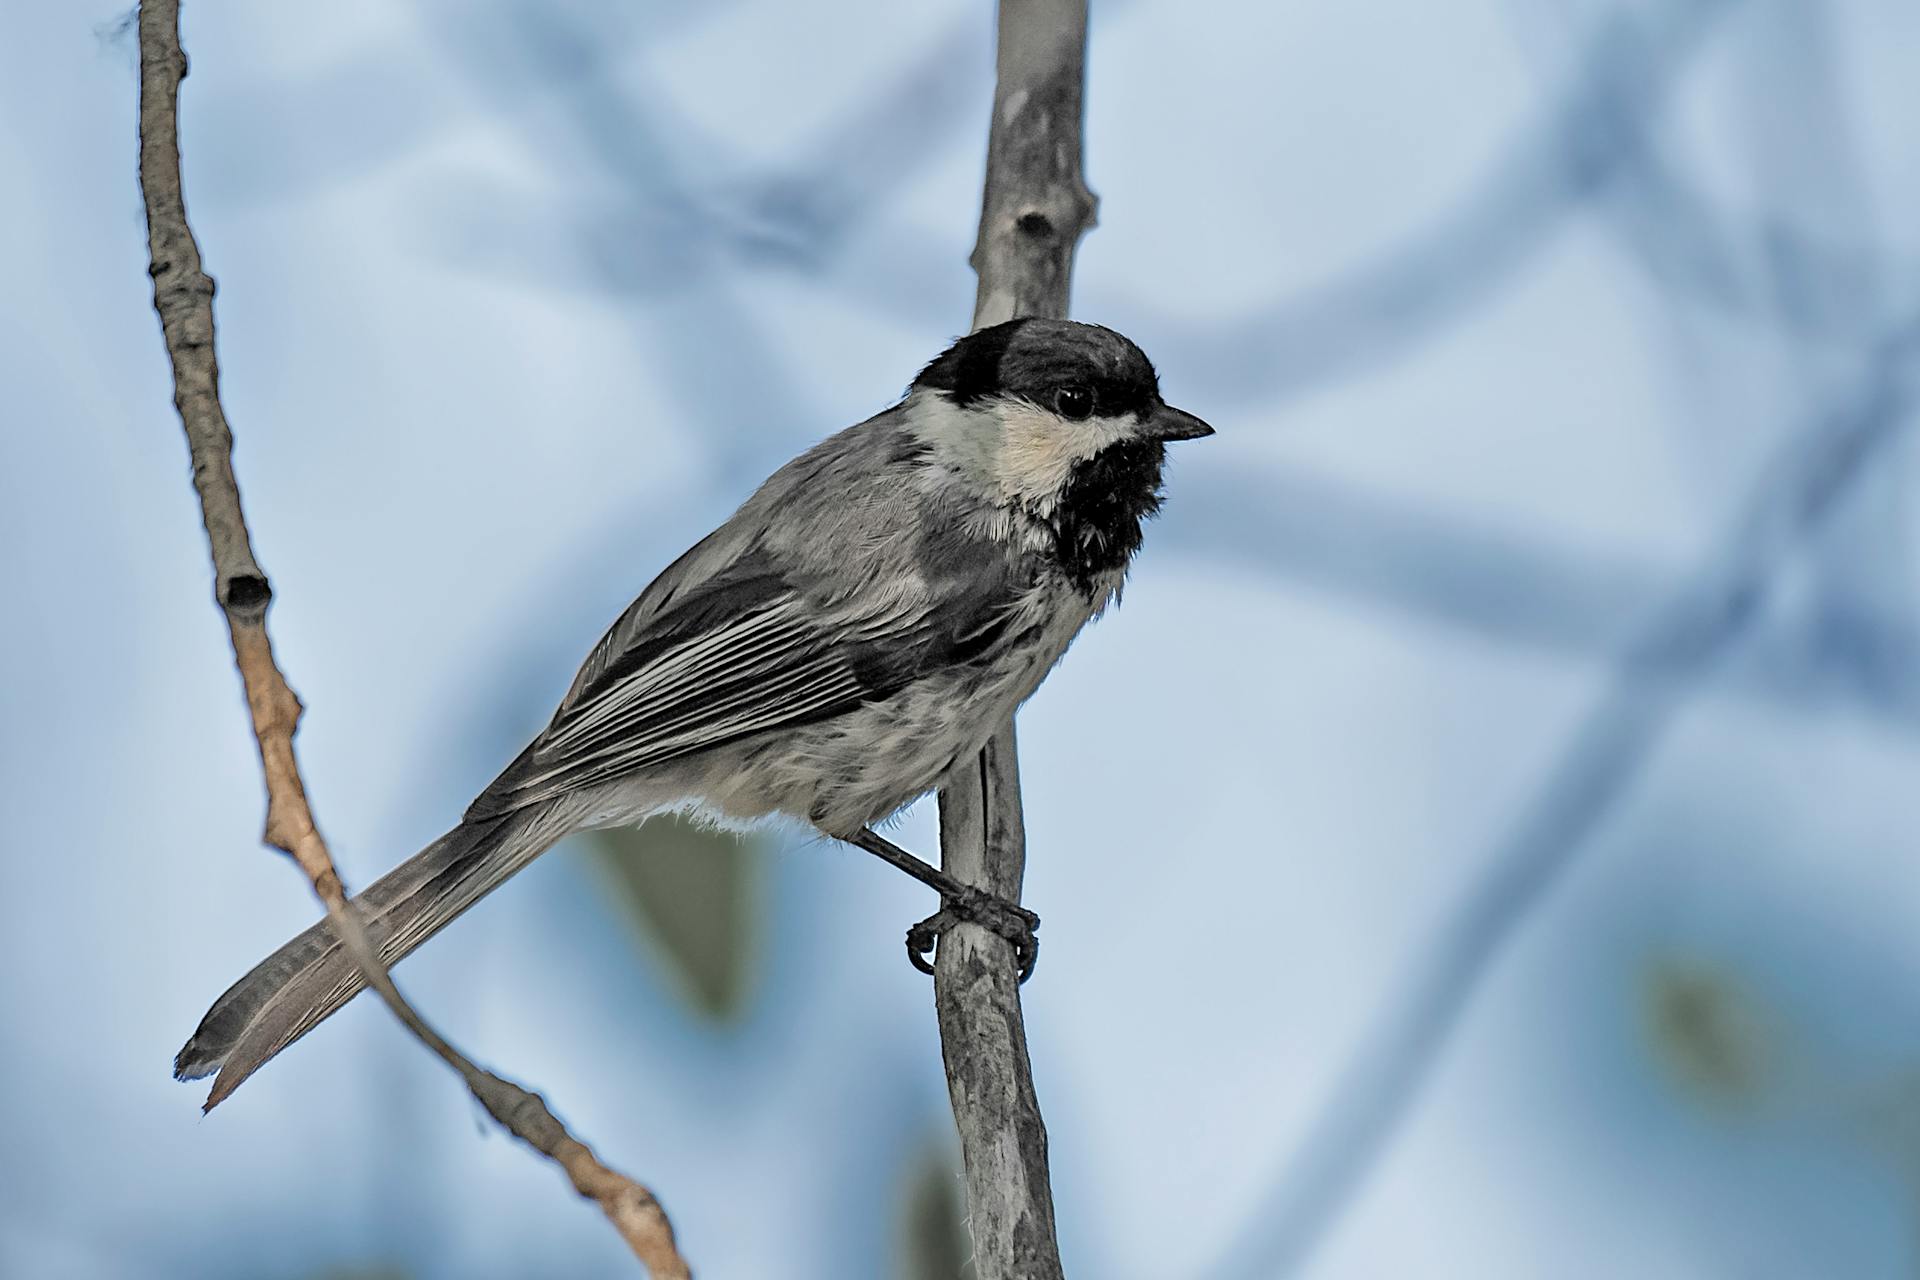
(933, 0, 1094, 1280)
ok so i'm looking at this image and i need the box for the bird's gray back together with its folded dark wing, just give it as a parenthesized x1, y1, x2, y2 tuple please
(467, 407, 1025, 821)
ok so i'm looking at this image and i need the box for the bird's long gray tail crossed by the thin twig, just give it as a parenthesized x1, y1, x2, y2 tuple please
(173, 810, 566, 1111)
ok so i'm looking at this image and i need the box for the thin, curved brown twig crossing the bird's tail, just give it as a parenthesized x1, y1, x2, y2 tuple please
(140, 0, 691, 1280)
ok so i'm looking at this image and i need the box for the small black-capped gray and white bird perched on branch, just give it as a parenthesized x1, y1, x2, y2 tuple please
(175, 317, 1213, 1109)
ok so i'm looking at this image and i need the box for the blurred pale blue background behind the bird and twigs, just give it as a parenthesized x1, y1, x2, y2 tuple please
(0, 0, 1920, 1280)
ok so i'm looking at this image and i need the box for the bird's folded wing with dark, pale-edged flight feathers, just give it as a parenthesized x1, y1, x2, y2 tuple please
(468, 555, 1008, 818)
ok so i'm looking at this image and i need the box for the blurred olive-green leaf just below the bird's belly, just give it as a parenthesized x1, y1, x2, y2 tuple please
(589, 816, 766, 1021)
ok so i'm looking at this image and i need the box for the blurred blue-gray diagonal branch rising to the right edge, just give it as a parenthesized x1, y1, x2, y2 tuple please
(1212, 315, 1920, 1276)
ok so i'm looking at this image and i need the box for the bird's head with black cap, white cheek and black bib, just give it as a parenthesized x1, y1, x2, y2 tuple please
(908, 319, 1213, 594)
